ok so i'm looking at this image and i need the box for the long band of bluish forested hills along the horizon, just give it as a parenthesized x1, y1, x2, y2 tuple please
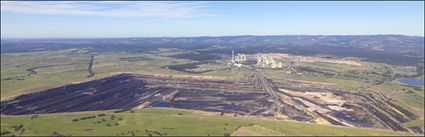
(1, 35, 424, 65)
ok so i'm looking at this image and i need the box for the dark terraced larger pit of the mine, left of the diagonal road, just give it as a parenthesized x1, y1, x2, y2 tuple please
(1, 74, 272, 115)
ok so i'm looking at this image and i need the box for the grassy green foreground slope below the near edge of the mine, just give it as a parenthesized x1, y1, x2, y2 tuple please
(1, 108, 409, 136)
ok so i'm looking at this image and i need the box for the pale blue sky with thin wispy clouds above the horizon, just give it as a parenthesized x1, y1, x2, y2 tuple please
(1, 1, 424, 38)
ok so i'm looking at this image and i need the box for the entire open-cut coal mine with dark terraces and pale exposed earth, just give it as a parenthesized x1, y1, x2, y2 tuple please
(1, 72, 423, 132)
